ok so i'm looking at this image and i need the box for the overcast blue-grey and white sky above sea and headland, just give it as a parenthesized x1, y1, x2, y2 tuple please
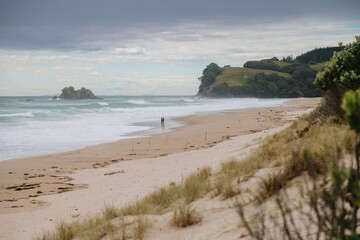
(0, 0, 360, 96)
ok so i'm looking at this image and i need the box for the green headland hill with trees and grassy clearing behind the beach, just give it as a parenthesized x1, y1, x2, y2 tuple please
(197, 47, 341, 98)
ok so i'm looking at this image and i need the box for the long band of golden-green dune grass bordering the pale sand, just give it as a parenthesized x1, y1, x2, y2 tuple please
(35, 115, 356, 240)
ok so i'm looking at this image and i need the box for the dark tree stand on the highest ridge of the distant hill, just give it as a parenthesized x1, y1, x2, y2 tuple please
(295, 47, 343, 64)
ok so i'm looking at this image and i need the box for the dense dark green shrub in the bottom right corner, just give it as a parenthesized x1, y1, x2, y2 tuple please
(310, 163, 360, 239)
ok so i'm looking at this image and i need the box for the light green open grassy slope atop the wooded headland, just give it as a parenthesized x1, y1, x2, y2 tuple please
(215, 67, 290, 86)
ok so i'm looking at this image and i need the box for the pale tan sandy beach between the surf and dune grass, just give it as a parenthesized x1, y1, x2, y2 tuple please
(0, 98, 320, 239)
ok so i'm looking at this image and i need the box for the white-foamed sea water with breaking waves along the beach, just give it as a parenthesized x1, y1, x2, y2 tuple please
(0, 96, 286, 160)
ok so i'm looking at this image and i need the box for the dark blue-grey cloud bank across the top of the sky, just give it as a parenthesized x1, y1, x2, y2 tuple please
(0, 0, 360, 51)
